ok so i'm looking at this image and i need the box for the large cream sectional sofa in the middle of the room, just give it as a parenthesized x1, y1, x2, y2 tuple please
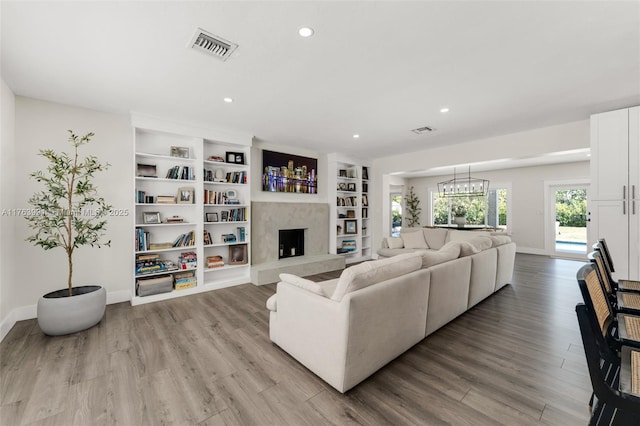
(267, 228, 515, 392)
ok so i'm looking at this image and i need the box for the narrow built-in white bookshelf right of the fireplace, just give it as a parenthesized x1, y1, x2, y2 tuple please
(329, 154, 371, 263)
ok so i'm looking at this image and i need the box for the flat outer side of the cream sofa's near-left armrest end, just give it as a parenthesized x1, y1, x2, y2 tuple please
(269, 282, 349, 390)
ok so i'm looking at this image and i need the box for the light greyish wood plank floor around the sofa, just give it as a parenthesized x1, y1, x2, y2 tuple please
(0, 254, 591, 426)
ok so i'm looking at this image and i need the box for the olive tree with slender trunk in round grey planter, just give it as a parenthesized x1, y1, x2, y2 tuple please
(26, 130, 111, 336)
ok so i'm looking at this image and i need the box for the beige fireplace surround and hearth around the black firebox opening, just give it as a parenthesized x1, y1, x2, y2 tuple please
(251, 202, 344, 284)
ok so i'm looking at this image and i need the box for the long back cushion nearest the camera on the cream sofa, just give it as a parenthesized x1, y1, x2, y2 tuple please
(331, 251, 422, 301)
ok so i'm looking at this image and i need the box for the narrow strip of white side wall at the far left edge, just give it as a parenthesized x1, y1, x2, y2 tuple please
(0, 80, 16, 340)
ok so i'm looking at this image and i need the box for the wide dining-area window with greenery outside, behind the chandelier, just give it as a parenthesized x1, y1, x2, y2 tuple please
(432, 188, 507, 228)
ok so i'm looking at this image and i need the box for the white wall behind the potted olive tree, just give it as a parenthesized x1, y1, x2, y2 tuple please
(0, 95, 133, 336)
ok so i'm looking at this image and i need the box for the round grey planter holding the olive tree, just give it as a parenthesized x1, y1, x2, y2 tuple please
(38, 285, 107, 336)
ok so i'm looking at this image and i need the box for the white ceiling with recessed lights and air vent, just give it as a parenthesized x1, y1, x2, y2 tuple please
(0, 0, 640, 159)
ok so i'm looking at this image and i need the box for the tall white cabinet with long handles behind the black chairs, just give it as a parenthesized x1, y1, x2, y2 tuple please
(589, 107, 640, 279)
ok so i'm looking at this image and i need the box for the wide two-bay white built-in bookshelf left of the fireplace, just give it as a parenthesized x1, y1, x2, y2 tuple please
(131, 115, 251, 305)
